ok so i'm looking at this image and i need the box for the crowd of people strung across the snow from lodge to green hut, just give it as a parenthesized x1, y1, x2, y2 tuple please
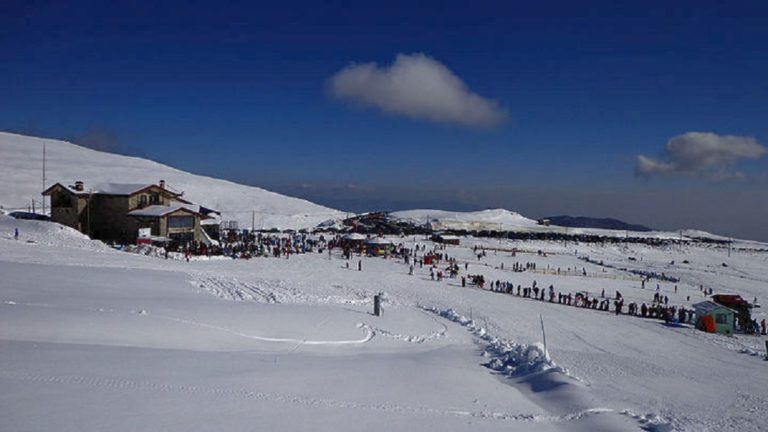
(159, 231, 766, 334)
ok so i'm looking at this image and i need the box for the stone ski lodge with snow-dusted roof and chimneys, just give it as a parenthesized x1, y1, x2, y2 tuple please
(43, 180, 215, 244)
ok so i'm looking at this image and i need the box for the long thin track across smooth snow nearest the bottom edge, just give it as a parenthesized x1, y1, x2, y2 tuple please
(0, 371, 624, 423)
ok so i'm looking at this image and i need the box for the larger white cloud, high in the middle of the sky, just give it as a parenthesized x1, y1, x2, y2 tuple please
(329, 54, 506, 127)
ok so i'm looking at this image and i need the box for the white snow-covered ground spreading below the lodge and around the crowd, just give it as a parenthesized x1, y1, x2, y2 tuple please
(0, 216, 768, 431)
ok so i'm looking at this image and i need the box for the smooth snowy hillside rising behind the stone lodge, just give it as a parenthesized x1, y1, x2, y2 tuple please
(0, 132, 341, 229)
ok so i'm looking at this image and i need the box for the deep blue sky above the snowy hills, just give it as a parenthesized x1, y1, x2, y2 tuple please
(0, 1, 768, 239)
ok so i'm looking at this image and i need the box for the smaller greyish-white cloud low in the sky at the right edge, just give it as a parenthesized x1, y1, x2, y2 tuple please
(635, 132, 768, 180)
